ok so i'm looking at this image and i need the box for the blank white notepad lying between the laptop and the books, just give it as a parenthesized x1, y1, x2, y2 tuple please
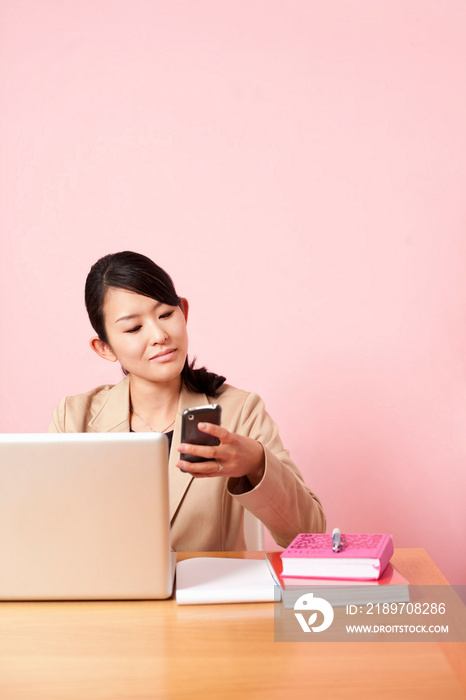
(176, 557, 274, 605)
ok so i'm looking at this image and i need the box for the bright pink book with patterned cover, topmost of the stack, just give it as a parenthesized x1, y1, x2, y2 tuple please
(281, 532, 393, 580)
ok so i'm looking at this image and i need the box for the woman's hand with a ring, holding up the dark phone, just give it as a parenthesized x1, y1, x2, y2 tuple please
(176, 423, 265, 486)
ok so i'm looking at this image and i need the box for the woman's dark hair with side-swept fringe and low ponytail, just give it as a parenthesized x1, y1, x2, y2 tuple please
(84, 251, 225, 398)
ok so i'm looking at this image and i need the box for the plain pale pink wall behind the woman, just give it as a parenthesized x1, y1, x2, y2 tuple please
(0, 0, 466, 583)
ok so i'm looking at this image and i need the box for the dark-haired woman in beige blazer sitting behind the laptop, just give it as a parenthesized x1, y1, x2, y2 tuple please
(49, 252, 325, 551)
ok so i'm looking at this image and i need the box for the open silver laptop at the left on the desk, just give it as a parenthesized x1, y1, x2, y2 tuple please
(0, 433, 176, 600)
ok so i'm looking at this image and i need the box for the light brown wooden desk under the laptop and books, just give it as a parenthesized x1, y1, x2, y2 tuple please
(0, 549, 466, 700)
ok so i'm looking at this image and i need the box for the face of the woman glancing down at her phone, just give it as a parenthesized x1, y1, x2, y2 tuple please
(91, 287, 188, 383)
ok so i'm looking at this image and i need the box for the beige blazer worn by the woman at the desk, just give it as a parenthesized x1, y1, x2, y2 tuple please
(48, 377, 325, 551)
